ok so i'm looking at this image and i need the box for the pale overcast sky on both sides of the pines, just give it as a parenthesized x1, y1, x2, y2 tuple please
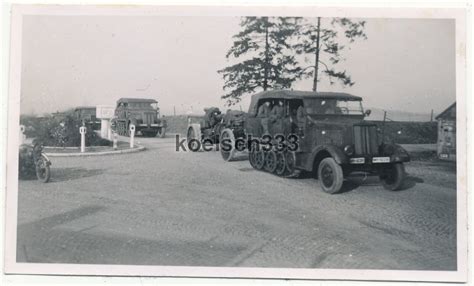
(21, 16, 456, 115)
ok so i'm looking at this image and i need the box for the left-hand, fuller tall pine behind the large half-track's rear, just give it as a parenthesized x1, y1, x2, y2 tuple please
(218, 17, 302, 105)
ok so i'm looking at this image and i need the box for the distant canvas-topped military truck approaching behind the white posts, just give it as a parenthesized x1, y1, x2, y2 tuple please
(112, 98, 166, 137)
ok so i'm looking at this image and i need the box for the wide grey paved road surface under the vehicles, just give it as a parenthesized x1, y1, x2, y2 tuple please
(17, 137, 456, 270)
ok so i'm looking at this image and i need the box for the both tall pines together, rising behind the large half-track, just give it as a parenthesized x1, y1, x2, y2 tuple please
(218, 17, 367, 105)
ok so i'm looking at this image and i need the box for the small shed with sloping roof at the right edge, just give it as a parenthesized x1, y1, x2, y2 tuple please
(436, 102, 456, 161)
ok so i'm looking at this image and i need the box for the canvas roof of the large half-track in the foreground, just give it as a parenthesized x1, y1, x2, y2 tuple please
(252, 90, 362, 100)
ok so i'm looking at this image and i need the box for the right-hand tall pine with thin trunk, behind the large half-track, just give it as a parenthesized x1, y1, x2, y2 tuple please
(294, 17, 367, 91)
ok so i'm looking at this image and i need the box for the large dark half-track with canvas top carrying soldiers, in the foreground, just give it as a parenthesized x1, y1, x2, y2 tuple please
(221, 90, 410, 194)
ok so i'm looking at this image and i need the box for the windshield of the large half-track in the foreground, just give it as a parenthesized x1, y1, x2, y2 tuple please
(305, 99, 364, 115)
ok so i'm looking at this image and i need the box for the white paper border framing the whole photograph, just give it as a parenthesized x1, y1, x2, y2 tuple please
(4, 5, 468, 282)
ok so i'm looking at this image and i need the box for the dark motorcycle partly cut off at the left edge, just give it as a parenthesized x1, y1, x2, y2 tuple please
(19, 142, 51, 183)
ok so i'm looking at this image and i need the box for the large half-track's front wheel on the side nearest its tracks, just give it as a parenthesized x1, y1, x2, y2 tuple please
(318, 157, 344, 194)
